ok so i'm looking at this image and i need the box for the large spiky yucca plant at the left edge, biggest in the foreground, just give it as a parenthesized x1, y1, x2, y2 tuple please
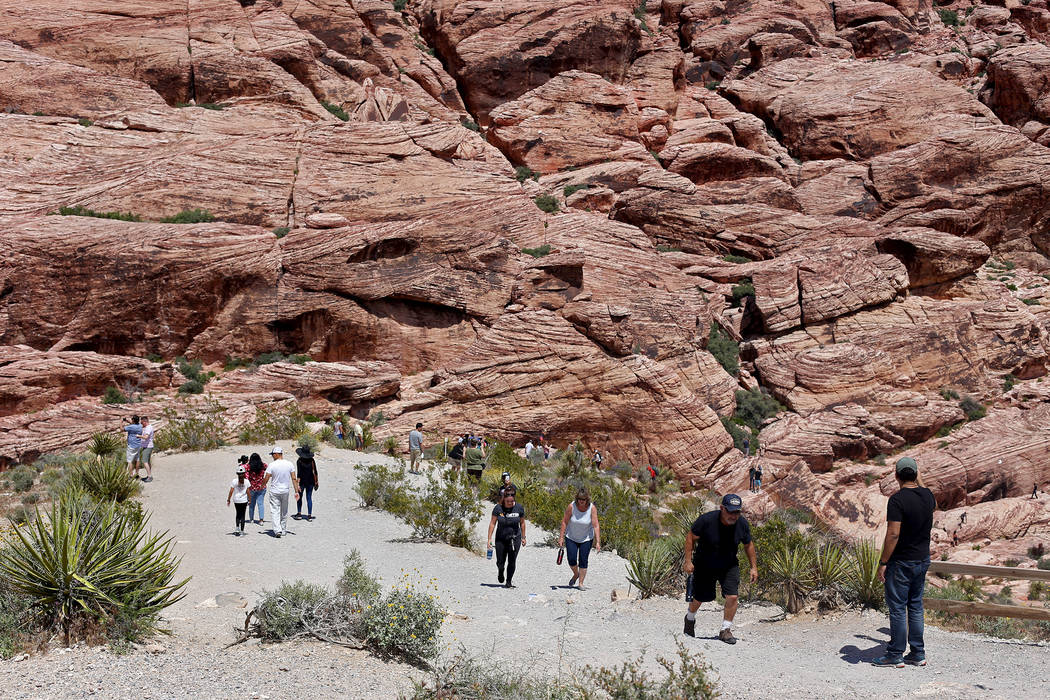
(0, 493, 189, 645)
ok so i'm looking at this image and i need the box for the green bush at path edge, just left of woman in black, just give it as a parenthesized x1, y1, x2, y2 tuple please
(398, 472, 484, 549)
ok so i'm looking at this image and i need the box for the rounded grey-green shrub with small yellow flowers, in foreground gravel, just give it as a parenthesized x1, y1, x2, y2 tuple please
(364, 574, 445, 662)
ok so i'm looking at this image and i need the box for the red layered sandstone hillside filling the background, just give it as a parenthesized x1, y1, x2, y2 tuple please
(0, 0, 1050, 554)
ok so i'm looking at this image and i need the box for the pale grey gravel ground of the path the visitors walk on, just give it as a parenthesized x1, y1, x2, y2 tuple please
(0, 444, 1050, 698)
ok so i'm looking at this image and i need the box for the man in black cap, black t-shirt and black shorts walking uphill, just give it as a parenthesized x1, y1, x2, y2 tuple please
(684, 493, 758, 644)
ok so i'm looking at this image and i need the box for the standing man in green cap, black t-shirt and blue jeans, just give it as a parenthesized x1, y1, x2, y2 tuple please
(872, 457, 937, 669)
